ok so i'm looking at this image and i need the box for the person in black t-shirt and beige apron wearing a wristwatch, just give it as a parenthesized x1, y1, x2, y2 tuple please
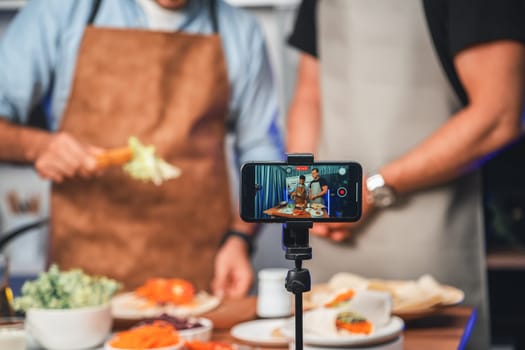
(287, 0, 525, 349)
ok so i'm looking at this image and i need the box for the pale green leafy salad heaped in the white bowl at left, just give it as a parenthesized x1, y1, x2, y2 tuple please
(13, 265, 120, 311)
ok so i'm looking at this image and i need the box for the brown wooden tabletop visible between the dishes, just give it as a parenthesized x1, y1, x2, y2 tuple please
(204, 297, 473, 350)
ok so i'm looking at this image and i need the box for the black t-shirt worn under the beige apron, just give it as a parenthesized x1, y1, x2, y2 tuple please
(288, 0, 525, 104)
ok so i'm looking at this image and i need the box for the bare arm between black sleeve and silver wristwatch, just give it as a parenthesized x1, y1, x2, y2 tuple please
(381, 41, 525, 193)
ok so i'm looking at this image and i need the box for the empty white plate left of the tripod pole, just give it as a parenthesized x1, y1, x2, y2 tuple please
(230, 318, 289, 346)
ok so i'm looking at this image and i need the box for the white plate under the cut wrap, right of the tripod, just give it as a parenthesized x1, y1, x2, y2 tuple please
(281, 316, 405, 346)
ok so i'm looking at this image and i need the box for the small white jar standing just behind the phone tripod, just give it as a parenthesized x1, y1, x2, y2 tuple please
(257, 268, 292, 318)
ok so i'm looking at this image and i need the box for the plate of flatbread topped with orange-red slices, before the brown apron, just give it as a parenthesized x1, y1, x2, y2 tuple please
(111, 278, 221, 319)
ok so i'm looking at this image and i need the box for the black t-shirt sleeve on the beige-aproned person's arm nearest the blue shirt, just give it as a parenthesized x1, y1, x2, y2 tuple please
(288, 0, 318, 57)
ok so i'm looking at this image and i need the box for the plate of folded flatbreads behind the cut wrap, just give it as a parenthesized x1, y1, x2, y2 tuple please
(305, 272, 465, 320)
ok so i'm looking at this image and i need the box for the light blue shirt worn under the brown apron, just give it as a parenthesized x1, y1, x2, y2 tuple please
(0, 0, 282, 162)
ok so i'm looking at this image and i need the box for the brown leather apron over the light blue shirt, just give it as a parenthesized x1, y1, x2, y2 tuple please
(51, 13, 232, 289)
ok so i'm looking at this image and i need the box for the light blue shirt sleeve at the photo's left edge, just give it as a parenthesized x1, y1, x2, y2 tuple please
(0, 1, 63, 123)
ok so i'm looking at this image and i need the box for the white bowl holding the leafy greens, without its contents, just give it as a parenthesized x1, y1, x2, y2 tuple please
(26, 304, 112, 350)
